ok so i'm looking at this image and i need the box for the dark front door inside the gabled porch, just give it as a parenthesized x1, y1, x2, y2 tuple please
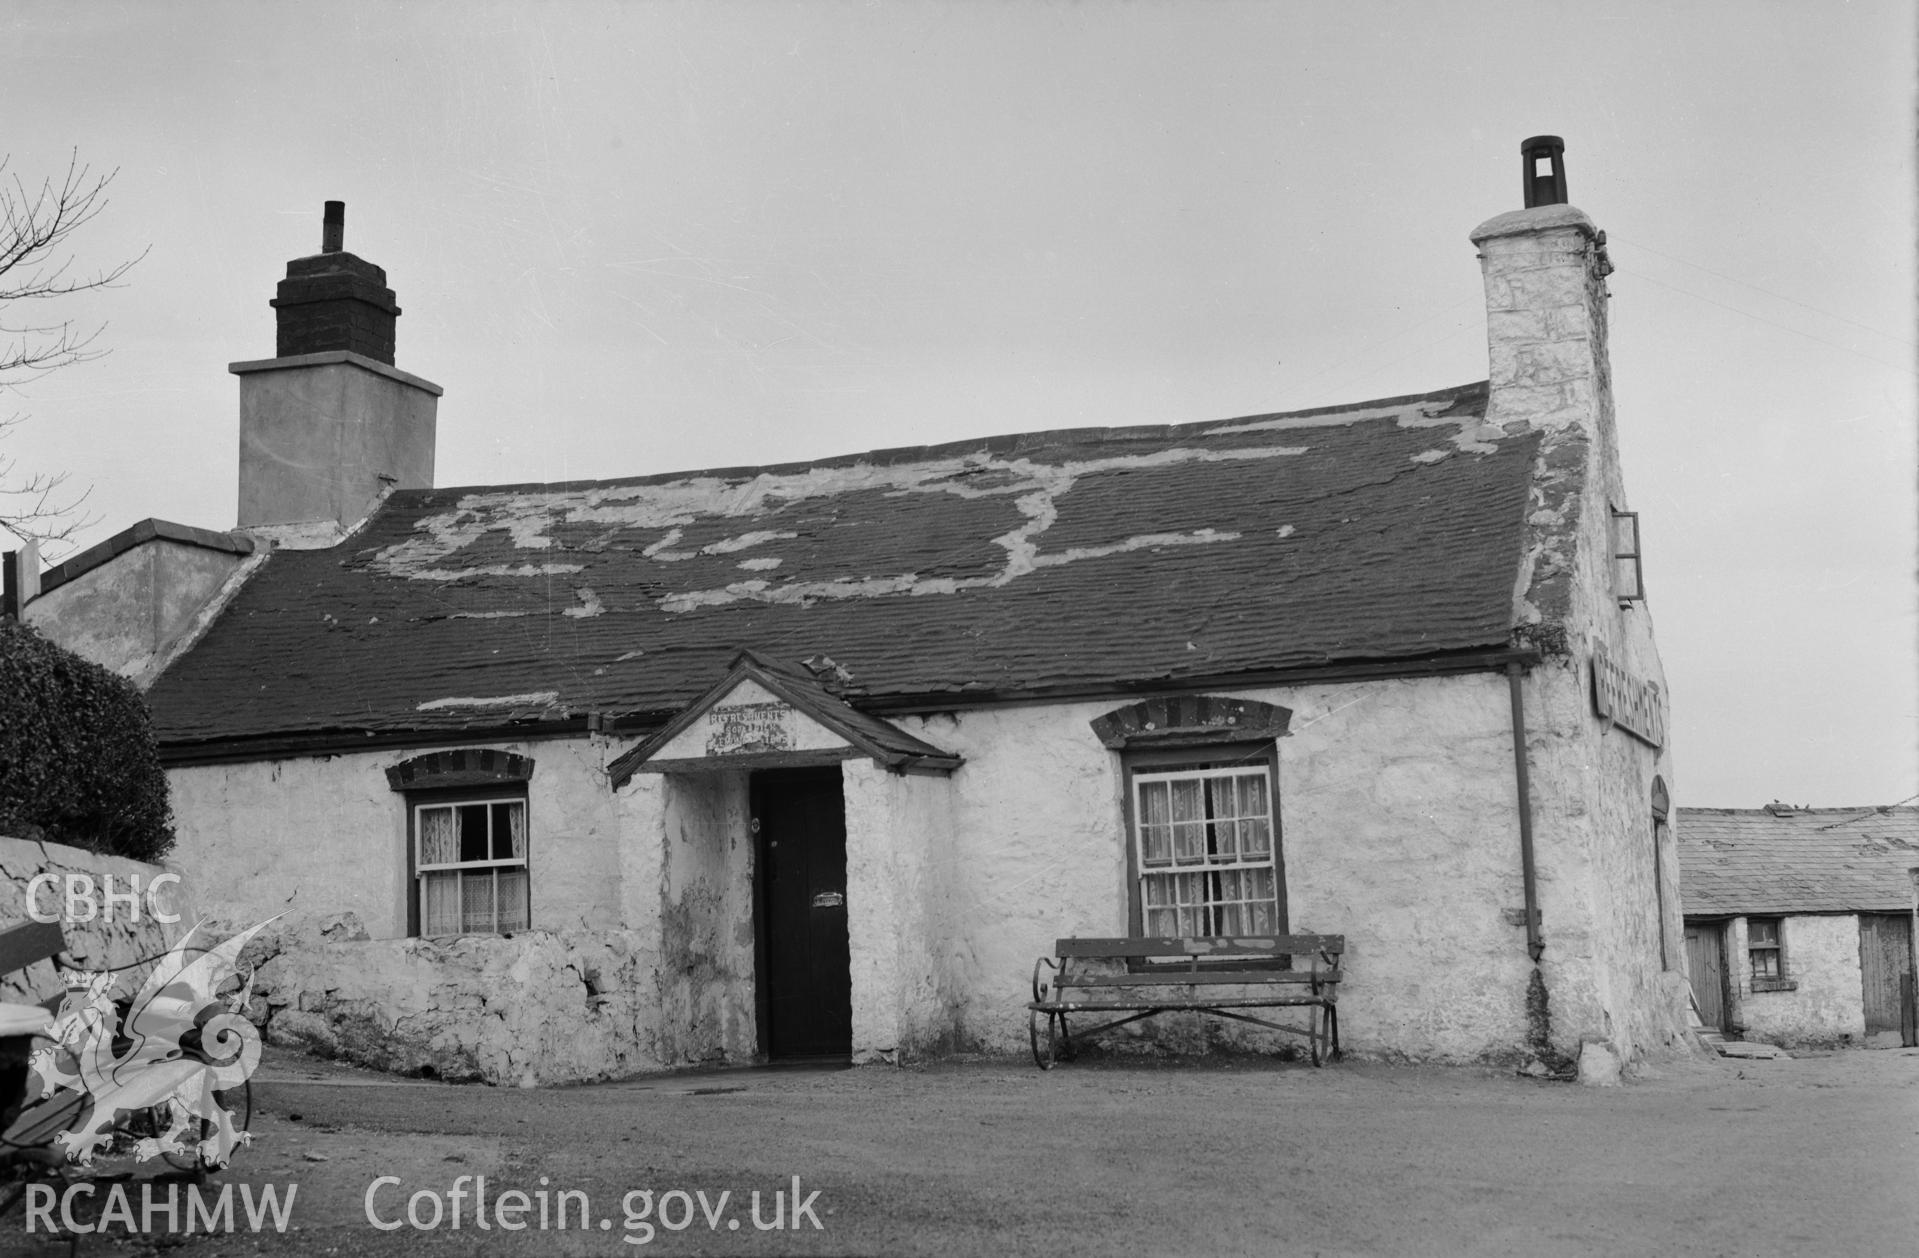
(752, 765, 852, 1059)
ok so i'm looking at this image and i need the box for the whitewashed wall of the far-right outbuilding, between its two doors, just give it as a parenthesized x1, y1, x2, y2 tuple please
(1725, 913, 1865, 1049)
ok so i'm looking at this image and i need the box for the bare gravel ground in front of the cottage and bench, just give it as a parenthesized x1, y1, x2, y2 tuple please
(0, 1049, 1919, 1258)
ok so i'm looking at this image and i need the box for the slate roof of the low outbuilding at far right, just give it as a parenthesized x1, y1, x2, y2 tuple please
(1675, 807, 1919, 917)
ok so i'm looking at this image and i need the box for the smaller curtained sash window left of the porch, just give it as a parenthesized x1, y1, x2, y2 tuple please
(413, 800, 528, 936)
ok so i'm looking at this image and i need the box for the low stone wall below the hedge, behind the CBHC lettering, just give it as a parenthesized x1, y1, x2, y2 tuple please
(0, 836, 194, 1003)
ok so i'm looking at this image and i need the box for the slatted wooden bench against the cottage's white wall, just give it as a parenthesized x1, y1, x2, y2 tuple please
(1027, 934, 1345, 1070)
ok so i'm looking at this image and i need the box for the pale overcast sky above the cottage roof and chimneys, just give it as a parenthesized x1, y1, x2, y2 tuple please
(0, 0, 1919, 807)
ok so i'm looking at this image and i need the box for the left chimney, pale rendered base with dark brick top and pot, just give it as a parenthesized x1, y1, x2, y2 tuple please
(226, 201, 441, 545)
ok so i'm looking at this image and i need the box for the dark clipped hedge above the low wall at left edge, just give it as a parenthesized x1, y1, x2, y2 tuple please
(0, 619, 173, 861)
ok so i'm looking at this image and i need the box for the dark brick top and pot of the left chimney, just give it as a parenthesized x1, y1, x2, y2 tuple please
(271, 201, 399, 364)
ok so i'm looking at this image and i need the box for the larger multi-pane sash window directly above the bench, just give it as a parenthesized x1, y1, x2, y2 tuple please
(1132, 763, 1282, 936)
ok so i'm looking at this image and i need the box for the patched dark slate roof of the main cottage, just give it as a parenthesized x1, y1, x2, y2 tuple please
(150, 384, 1539, 748)
